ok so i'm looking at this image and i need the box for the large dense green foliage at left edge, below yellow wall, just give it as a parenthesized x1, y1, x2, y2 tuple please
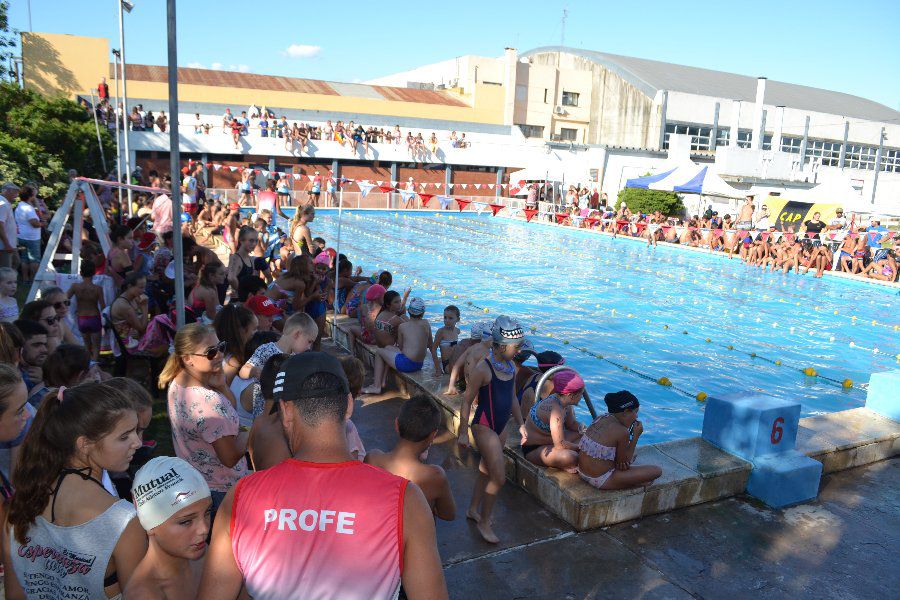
(0, 83, 115, 208)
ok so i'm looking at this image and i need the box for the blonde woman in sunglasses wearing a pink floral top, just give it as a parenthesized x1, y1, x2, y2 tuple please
(159, 323, 248, 515)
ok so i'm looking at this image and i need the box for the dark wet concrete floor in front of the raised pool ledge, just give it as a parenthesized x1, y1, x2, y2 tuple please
(342, 354, 900, 600)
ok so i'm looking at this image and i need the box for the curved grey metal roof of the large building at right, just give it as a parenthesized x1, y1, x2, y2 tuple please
(522, 46, 900, 123)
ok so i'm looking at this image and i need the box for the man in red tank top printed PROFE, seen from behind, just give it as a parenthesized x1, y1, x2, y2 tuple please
(199, 352, 447, 600)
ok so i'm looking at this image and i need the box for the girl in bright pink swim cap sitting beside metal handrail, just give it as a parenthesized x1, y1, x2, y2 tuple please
(522, 370, 584, 473)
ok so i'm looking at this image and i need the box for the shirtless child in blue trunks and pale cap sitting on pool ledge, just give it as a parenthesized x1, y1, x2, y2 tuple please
(362, 298, 438, 394)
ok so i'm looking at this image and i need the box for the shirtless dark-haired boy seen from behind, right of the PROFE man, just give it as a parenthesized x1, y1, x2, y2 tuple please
(366, 396, 456, 521)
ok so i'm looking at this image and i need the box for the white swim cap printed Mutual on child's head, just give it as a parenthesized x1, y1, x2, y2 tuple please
(131, 456, 210, 531)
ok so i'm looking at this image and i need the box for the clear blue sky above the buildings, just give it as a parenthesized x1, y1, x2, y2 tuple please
(10, 0, 900, 110)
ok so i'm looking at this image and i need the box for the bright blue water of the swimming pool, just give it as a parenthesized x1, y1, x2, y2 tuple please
(311, 211, 900, 443)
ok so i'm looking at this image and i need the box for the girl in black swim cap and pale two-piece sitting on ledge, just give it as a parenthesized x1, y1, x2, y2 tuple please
(578, 390, 662, 490)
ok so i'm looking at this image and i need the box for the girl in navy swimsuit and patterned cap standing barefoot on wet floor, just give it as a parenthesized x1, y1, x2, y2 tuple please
(456, 315, 526, 544)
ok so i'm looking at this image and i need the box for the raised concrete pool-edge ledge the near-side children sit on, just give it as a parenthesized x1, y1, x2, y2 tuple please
(328, 314, 900, 531)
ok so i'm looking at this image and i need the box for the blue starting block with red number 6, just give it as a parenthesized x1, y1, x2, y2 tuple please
(703, 393, 822, 508)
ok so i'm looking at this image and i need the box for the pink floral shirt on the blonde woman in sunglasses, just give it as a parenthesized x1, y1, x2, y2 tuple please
(169, 381, 249, 492)
